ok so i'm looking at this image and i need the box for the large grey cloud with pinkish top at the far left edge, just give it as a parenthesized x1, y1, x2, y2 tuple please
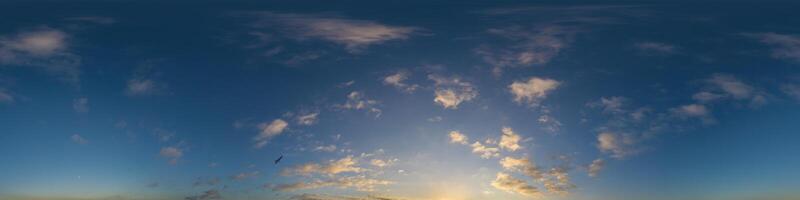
(0, 27, 81, 83)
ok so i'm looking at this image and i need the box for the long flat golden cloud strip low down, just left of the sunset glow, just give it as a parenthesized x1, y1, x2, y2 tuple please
(273, 175, 392, 191)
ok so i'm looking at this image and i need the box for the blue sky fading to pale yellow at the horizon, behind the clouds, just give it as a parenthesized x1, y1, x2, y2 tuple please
(0, 2, 800, 199)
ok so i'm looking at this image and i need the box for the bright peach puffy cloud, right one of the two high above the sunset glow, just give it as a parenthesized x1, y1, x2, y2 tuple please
(508, 77, 561, 106)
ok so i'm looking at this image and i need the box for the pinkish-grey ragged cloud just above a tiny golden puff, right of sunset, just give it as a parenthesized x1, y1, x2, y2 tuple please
(597, 132, 638, 159)
